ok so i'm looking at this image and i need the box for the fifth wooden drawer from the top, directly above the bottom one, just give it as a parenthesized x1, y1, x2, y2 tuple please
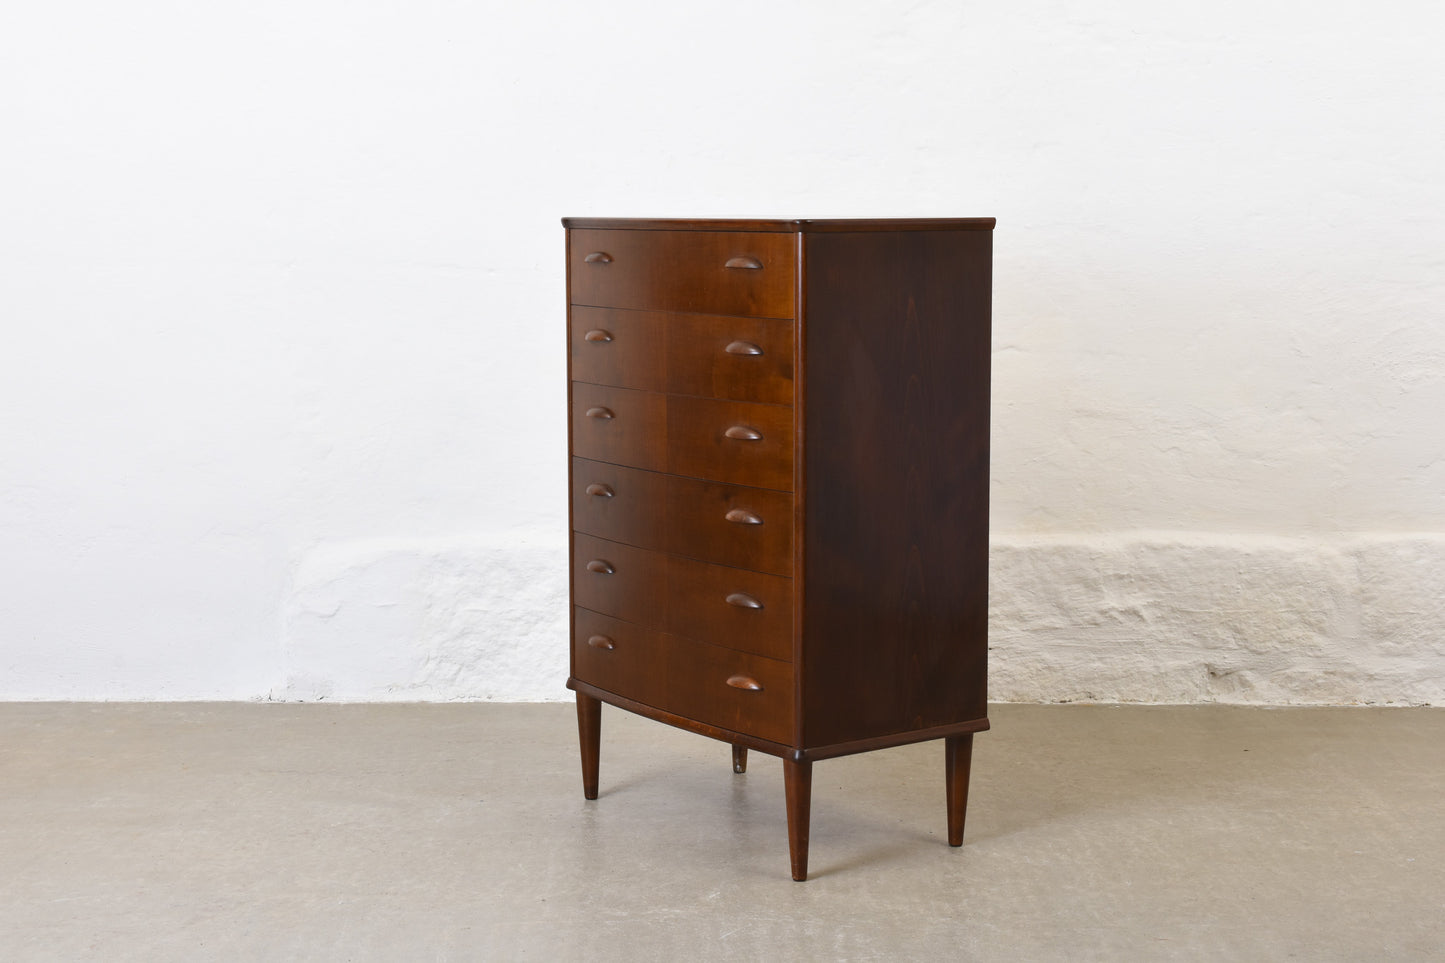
(572, 534, 793, 662)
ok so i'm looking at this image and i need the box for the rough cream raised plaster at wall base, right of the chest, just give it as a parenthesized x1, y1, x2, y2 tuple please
(990, 532, 1445, 706)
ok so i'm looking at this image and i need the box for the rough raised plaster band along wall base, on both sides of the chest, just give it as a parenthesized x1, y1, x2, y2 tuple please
(270, 532, 1445, 706)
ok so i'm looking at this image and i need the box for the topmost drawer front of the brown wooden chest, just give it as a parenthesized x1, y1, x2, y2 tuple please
(568, 230, 796, 318)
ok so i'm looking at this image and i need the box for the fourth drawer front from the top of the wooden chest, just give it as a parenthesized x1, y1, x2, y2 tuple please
(572, 458, 793, 575)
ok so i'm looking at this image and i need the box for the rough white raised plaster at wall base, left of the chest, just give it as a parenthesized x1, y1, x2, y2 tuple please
(278, 538, 569, 701)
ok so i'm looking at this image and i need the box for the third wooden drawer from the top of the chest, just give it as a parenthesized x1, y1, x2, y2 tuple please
(572, 382, 793, 492)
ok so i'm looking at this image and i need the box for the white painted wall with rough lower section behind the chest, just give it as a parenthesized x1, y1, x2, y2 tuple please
(0, 0, 1445, 703)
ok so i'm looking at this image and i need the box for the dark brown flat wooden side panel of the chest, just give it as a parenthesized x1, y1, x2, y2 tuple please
(801, 231, 991, 746)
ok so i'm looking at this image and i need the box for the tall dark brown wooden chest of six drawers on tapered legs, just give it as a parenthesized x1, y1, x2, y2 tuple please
(562, 218, 994, 879)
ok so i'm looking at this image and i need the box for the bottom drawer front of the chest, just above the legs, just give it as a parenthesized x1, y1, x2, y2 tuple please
(572, 607, 793, 745)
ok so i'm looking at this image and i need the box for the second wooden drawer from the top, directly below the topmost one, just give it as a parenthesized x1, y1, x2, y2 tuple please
(571, 305, 793, 405)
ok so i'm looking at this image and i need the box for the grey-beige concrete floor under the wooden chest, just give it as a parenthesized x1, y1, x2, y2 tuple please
(0, 703, 1445, 960)
